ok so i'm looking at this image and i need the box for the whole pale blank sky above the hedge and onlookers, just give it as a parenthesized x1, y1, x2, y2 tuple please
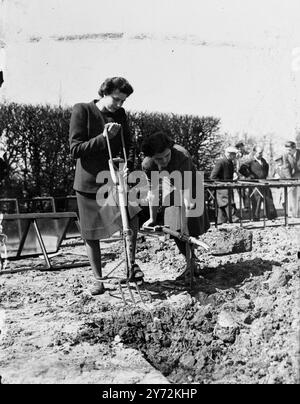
(0, 0, 300, 144)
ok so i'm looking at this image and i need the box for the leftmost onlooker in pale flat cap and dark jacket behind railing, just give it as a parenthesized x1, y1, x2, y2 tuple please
(210, 146, 239, 224)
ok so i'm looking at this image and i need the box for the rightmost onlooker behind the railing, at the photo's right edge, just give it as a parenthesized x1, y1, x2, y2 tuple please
(283, 140, 300, 217)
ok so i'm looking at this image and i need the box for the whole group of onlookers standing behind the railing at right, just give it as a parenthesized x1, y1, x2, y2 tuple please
(210, 141, 300, 224)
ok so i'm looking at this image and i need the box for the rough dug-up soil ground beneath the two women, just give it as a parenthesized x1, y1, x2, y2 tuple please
(0, 225, 300, 384)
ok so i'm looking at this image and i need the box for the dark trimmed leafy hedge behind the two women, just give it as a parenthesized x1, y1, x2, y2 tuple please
(0, 103, 223, 198)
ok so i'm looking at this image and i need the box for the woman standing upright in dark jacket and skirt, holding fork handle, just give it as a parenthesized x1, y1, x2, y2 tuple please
(70, 77, 143, 295)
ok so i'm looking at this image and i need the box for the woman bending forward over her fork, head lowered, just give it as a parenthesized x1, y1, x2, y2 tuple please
(142, 132, 210, 279)
